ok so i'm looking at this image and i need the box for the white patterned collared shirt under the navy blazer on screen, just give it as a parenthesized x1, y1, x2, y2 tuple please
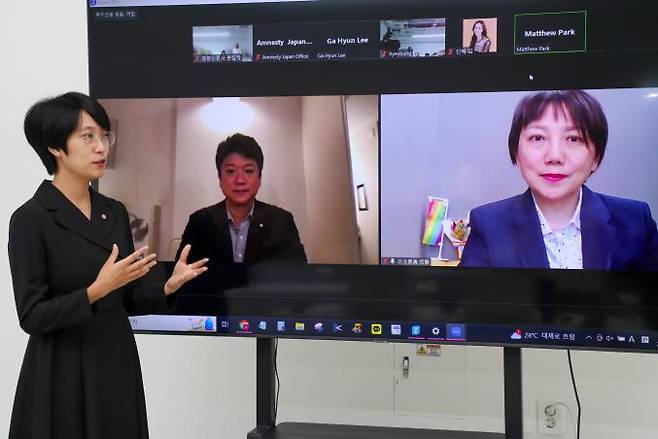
(532, 188, 583, 269)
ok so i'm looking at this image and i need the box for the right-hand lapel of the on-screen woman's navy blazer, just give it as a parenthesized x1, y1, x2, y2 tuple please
(580, 186, 614, 270)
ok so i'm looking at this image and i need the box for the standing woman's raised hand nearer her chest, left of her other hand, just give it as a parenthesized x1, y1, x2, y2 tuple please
(87, 244, 156, 304)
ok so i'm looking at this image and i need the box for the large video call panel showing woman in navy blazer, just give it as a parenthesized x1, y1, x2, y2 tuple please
(381, 89, 658, 270)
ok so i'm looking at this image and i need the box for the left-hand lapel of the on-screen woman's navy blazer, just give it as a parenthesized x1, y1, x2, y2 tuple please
(512, 189, 548, 268)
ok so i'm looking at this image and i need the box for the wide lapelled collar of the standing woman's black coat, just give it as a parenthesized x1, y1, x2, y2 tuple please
(34, 180, 119, 251)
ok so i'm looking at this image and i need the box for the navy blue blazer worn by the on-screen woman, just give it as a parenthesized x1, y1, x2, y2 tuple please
(460, 186, 658, 270)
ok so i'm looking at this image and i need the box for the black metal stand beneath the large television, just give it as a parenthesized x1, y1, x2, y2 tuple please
(247, 338, 523, 439)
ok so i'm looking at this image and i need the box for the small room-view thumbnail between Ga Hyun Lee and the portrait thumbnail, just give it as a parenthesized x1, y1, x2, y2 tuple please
(379, 18, 446, 58)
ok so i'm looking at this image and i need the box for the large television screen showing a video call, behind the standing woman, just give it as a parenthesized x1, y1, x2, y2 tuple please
(88, 0, 658, 351)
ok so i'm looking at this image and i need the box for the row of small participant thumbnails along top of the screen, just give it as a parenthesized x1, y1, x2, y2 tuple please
(192, 11, 587, 63)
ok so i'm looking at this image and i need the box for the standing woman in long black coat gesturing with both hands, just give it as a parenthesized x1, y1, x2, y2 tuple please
(9, 93, 207, 439)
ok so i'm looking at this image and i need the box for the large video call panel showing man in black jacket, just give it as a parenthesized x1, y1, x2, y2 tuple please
(99, 96, 379, 265)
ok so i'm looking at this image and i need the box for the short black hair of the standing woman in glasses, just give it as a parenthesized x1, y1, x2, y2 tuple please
(23, 91, 110, 175)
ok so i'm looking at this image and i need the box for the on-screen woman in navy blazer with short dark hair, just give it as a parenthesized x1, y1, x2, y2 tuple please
(460, 90, 658, 270)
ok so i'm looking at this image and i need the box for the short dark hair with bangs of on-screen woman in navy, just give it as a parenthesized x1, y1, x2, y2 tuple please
(507, 90, 608, 165)
